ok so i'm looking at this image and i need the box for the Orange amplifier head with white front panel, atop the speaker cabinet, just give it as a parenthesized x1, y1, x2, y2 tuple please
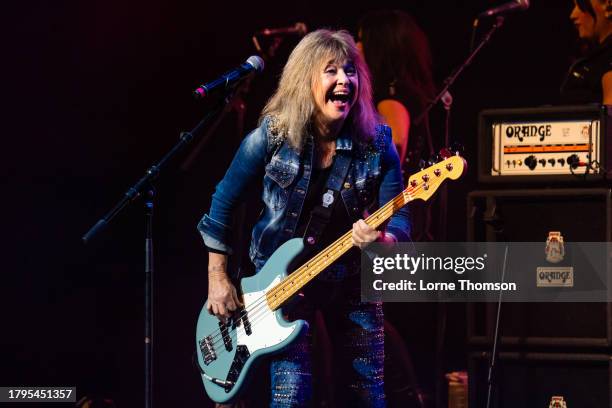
(478, 105, 612, 183)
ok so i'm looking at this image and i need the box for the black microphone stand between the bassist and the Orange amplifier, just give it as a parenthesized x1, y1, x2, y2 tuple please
(415, 16, 504, 406)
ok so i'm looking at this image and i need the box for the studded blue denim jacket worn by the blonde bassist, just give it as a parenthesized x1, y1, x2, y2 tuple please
(198, 118, 410, 270)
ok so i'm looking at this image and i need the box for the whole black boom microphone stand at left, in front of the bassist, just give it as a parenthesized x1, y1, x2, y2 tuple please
(82, 88, 233, 408)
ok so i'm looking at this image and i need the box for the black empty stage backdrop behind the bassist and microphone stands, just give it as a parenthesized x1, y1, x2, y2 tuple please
(0, 0, 576, 407)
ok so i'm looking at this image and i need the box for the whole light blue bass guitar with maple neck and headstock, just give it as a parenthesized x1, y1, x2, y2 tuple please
(196, 156, 467, 403)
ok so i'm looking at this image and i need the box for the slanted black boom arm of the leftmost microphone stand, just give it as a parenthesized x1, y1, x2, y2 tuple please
(81, 98, 226, 244)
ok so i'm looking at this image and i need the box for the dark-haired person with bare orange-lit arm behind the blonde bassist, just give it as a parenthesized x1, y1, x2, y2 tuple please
(357, 10, 436, 170)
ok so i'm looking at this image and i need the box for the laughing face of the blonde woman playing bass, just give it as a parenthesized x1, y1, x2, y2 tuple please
(312, 61, 359, 128)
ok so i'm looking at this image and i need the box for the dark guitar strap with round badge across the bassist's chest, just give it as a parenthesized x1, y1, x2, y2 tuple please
(304, 151, 352, 247)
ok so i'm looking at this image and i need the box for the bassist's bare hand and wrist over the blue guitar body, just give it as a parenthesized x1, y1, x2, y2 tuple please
(206, 252, 242, 322)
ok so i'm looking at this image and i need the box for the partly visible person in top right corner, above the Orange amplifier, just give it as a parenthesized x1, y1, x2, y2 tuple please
(561, 0, 612, 105)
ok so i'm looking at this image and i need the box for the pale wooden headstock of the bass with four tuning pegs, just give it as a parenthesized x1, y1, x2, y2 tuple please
(404, 155, 467, 201)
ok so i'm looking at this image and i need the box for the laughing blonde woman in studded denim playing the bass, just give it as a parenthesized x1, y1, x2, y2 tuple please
(198, 30, 410, 407)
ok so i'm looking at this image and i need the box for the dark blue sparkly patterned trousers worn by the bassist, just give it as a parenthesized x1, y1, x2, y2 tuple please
(270, 276, 385, 408)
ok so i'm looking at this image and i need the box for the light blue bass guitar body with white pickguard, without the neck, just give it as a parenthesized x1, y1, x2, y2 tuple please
(196, 238, 307, 403)
